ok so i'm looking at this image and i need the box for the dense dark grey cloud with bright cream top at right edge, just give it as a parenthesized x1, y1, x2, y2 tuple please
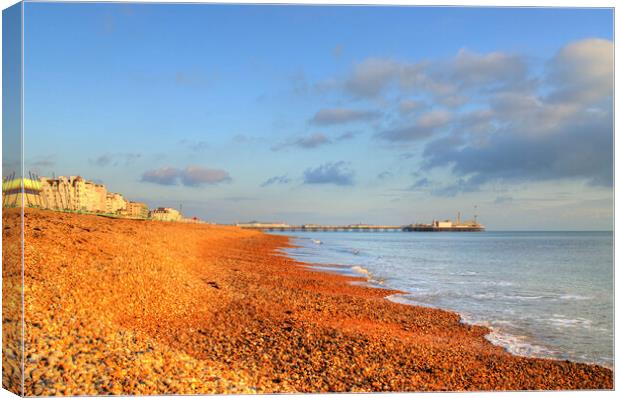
(424, 39, 613, 192)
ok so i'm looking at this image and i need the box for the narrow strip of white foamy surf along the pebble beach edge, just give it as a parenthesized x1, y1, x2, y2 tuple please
(276, 231, 614, 372)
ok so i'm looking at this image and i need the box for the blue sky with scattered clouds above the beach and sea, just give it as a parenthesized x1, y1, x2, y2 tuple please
(17, 3, 613, 230)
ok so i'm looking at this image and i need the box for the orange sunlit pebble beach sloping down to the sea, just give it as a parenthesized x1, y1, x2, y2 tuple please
(3, 210, 613, 395)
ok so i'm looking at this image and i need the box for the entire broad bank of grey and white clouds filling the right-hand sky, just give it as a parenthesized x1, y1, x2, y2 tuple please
(324, 38, 614, 195)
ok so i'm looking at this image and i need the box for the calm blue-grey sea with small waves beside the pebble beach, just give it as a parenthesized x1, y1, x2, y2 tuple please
(274, 232, 614, 368)
